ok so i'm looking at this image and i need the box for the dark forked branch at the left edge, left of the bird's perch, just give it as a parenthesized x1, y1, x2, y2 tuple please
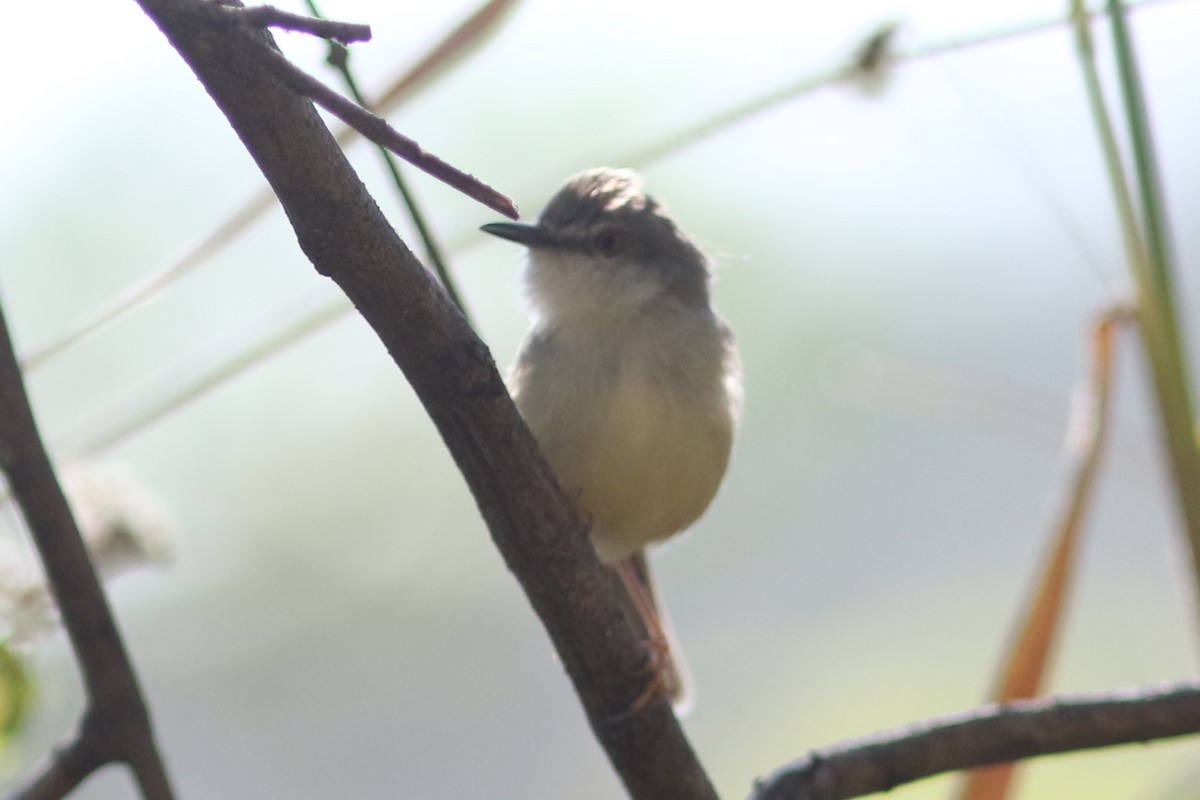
(0, 298, 172, 800)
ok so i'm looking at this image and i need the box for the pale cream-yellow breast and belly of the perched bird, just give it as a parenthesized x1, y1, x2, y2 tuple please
(514, 317, 736, 563)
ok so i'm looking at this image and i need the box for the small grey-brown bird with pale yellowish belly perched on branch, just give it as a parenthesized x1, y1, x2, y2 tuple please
(482, 167, 742, 710)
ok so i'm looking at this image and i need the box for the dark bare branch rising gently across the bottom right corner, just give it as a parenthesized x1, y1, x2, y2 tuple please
(750, 680, 1200, 800)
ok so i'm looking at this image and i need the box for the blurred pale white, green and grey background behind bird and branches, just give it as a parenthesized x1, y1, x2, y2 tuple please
(0, 0, 1200, 800)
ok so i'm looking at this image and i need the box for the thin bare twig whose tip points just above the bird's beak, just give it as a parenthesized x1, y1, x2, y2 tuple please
(248, 35, 520, 219)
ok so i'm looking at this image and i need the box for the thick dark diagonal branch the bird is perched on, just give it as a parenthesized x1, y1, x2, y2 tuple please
(132, 0, 716, 800)
